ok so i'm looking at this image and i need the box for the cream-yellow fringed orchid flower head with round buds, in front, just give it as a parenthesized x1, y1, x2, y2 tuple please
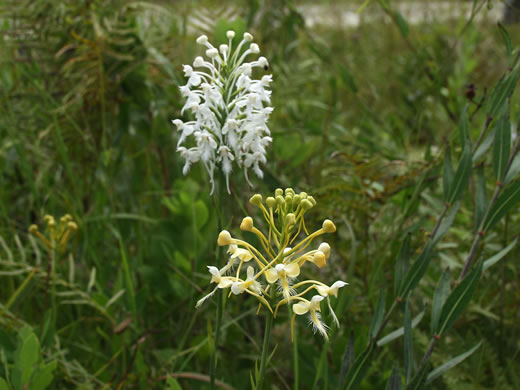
(197, 188, 347, 339)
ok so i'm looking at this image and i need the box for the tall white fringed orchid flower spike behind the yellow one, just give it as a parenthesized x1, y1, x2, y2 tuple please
(172, 31, 273, 192)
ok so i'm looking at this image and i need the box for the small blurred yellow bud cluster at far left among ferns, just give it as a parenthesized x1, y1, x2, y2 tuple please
(29, 214, 78, 252)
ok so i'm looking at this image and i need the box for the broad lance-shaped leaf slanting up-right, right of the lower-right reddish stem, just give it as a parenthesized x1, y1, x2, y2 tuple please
(435, 261, 482, 336)
